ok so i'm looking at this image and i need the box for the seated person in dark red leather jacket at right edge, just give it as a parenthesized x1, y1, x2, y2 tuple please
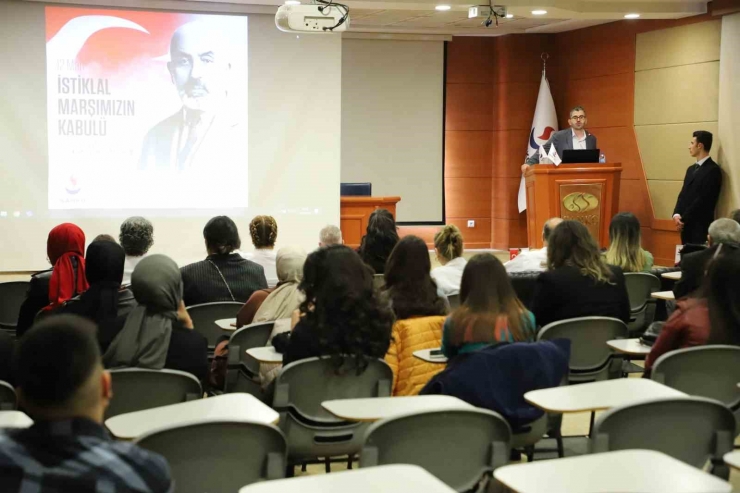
(645, 248, 740, 377)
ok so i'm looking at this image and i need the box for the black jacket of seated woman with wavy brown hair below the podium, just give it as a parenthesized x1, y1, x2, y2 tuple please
(531, 265, 630, 327)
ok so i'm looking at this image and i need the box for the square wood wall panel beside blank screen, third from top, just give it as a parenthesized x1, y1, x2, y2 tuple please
(445, 130, 491, 178)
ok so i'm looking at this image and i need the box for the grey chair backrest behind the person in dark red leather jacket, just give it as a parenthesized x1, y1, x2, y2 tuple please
(650, 345, 740, 410)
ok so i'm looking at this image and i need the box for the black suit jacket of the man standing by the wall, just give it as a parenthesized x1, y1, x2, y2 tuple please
(673, 158, 722, 243)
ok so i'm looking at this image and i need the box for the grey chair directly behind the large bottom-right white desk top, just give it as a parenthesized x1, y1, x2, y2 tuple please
(590, 397, 735, 479)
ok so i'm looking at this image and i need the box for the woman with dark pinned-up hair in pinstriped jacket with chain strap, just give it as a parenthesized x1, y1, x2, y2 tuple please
(181, 216, 267, 306)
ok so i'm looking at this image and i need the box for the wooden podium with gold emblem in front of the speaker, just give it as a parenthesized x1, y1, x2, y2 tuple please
(524, 163, 622, 248)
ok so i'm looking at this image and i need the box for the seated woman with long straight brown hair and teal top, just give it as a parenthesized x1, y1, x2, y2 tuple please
(442, 253, 537, 358)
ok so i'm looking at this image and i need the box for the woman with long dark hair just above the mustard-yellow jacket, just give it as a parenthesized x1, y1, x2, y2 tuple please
(384, 236, 447, 320)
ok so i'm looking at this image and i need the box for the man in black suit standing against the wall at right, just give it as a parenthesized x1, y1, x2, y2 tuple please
(673, 130, 722, 245)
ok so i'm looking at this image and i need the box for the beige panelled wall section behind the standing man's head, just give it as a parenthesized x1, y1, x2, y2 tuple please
(634, 20, 724, 219)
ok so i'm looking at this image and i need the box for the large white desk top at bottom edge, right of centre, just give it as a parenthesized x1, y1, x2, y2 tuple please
(493, 450, 732, 493)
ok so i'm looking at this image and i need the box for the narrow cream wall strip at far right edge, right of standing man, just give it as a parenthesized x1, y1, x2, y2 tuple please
(717, 13, 740, 216)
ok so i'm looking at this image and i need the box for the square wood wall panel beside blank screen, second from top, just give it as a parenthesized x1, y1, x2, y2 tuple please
(445, 84, 493, 130)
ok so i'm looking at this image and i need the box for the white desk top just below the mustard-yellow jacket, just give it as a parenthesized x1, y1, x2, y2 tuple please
(321, 395, 475, 421)
